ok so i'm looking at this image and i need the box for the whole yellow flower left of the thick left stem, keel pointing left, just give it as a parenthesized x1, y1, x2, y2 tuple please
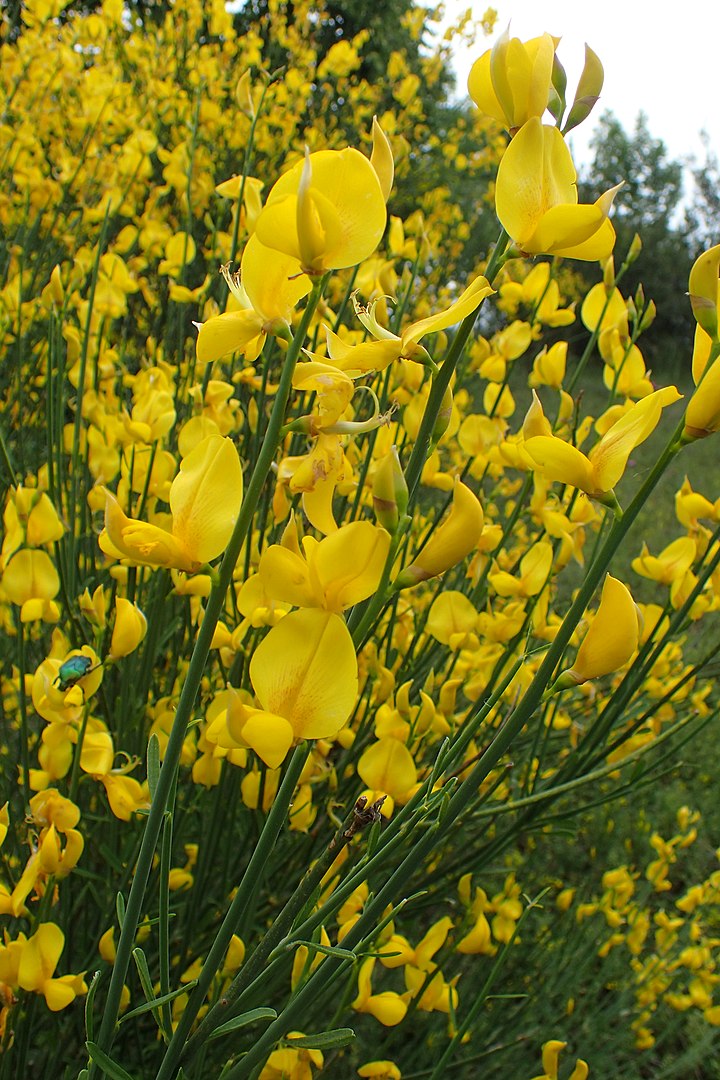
(99, 435, 243, 573)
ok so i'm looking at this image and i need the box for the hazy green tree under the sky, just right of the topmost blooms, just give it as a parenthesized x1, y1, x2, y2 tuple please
(580, 112, 696, 374)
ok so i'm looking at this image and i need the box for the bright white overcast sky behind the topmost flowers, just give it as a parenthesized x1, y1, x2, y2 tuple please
(446, 0, 720, 174)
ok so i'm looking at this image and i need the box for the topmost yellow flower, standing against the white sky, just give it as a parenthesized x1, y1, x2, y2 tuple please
(467, 30, 559, 131)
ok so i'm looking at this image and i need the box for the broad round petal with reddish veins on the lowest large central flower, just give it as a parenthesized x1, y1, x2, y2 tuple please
(249, 609, 357, 739)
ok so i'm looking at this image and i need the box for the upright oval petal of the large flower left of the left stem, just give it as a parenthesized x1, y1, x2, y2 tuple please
(169, 435, 243, 564)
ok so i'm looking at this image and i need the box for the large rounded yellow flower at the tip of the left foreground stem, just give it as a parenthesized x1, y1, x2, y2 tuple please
(256, 147, 386, 275)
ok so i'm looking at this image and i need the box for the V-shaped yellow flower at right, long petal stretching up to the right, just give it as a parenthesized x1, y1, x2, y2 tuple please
(524, 387, 681, 499)
